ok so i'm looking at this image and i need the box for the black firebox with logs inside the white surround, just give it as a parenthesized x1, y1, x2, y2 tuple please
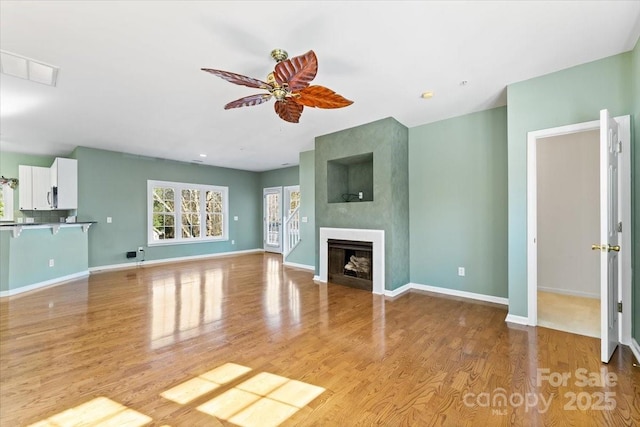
(327, 239, 373, 291)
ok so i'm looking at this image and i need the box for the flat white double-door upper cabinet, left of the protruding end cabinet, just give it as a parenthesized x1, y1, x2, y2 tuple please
(18, 165, 52, 211)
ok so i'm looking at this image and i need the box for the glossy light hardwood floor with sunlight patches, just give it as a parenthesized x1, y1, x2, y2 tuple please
(0, 254, 640, 427)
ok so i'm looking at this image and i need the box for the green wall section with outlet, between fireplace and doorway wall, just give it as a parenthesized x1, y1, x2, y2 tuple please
(409, 107, 508, 298)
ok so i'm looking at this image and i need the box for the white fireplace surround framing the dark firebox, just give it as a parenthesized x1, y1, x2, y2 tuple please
(314, 231, 385, 294)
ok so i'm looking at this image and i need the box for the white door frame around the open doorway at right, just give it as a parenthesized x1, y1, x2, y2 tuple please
(527, 116, 631, 345)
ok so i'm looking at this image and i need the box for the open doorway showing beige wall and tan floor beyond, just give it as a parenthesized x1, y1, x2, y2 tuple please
(536, 129, 600, 338)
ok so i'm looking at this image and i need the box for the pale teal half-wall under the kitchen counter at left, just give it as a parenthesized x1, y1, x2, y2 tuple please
(0, 227, 92, 292)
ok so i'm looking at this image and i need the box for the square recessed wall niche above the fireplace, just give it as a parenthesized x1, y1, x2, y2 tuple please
(327, 153, 373, 203)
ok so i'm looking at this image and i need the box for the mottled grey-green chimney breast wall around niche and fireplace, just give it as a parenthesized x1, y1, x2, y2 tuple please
(315, 117, 409, 290)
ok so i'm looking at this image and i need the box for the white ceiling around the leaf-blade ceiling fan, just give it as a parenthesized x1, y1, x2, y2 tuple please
(0, 0, 640, 171)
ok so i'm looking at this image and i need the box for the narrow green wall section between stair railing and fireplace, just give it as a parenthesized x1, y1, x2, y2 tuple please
(286, 151, 318, 273)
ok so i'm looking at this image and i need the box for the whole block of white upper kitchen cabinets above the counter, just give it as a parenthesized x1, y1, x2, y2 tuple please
(18, 158, 78, 210)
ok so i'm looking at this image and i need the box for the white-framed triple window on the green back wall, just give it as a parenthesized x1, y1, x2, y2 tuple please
(147, 181, 229, 245)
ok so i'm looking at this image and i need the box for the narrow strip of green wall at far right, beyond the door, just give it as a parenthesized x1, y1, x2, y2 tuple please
(631, 39, 640, 343)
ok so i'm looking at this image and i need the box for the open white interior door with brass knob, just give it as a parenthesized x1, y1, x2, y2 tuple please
(592, 110, 620, 363)
